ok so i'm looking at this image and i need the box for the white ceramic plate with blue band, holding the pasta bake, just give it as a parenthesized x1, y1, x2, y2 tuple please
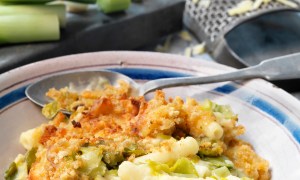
(0, 51, 300, 180)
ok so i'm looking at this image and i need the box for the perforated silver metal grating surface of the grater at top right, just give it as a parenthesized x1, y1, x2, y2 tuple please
(184, 0, 297, 48)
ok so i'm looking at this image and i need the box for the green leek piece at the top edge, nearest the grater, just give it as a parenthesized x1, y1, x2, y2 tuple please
(97, 0, 131, 13)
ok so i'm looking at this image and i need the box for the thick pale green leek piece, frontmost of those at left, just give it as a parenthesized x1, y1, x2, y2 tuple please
(0, 14, 60, 44)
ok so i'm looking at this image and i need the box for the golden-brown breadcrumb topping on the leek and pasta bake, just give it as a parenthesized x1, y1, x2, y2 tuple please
(7, 81, 270, 179)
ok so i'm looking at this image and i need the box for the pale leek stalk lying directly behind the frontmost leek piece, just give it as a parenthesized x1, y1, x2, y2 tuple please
(0, 4, 66, 27)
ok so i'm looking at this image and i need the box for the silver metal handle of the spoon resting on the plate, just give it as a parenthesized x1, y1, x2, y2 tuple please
(139, 53, 300, 95)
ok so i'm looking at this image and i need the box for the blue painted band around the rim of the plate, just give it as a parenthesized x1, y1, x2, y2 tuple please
(0, 68, 300, 144)
